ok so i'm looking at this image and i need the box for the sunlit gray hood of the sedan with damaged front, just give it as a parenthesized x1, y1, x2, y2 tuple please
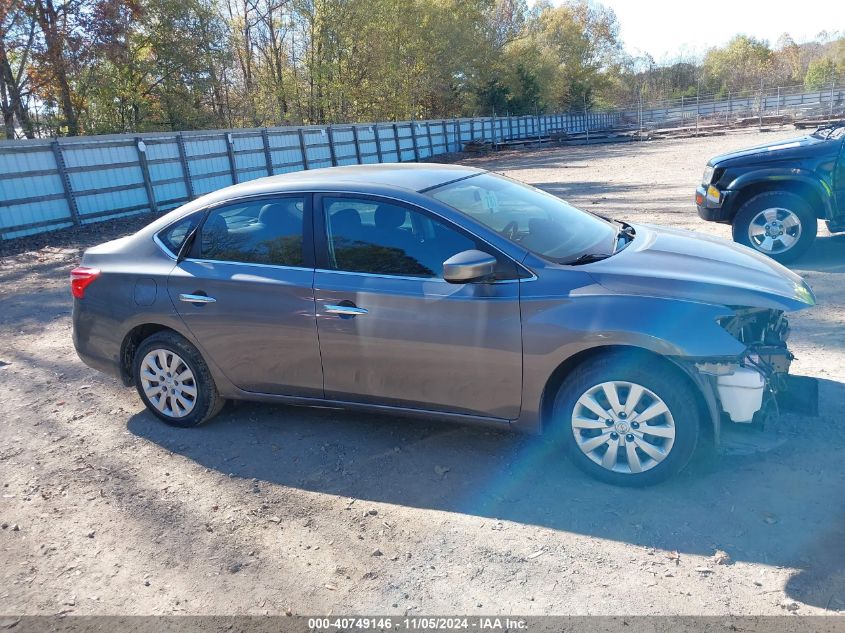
(583, 225, 816, 311)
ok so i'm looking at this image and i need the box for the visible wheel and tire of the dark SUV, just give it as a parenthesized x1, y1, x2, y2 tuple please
(733, 191, 818, 264)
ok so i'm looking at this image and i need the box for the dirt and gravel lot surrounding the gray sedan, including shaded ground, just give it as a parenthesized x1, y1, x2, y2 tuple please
(0, 126, 845, 615)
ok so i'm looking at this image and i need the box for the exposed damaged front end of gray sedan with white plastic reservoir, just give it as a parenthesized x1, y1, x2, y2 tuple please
(695, 307, 818, 427)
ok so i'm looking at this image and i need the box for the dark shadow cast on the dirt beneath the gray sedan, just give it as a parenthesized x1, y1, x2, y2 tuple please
(129, 381, 845, 608)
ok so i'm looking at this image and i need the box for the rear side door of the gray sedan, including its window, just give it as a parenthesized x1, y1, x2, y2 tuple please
(168, 195, 323, 397)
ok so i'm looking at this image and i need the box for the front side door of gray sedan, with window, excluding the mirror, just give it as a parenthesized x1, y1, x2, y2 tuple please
(314, 194, 522, 419)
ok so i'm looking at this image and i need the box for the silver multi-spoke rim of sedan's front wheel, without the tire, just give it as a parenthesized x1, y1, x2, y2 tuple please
(571, 380, 675, 474)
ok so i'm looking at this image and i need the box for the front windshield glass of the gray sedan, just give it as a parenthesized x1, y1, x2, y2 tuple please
(426, 173, 619, 264)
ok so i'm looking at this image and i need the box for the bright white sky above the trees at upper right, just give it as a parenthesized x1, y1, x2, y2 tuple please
(599, 0, 845, 62)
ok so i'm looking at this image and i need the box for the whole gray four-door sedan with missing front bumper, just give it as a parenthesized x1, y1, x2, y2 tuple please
(71, 164, 815, 485)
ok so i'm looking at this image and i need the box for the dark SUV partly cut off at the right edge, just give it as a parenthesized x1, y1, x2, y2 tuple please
(695, 121, 845, 262)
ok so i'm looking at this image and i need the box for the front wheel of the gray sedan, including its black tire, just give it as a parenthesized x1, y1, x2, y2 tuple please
(554, 353, 700, 487)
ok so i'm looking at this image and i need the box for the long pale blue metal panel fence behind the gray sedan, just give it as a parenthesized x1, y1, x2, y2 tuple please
(0, 113, 619, 239)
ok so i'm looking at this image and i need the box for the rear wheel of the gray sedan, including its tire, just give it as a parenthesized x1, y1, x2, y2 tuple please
(132, 331, 225, 428)
